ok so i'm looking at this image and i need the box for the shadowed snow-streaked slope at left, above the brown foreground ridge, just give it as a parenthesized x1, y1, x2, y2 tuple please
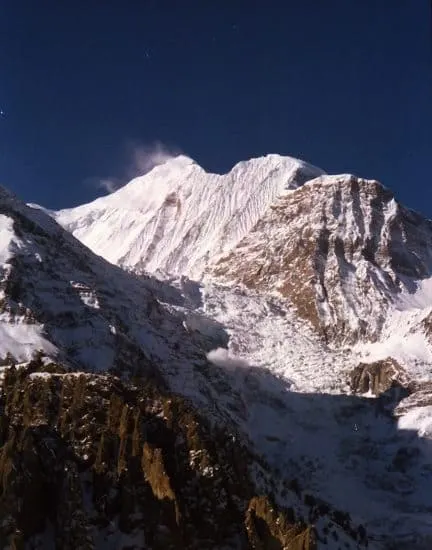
(0, 183, 204, 382)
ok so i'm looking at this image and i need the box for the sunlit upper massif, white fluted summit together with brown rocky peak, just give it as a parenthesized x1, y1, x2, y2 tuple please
(55, 155, 432, 350)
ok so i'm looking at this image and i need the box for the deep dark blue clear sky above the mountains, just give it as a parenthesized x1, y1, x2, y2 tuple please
(0, 0, 432, 216)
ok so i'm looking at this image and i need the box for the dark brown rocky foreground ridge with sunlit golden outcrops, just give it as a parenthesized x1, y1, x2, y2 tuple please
(0, 358, 367, 550)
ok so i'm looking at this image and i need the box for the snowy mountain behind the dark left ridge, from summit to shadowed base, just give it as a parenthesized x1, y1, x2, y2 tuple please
(52, 155, 432, 548)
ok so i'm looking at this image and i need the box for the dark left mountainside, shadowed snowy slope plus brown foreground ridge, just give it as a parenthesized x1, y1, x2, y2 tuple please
(0, 188, 367, 550)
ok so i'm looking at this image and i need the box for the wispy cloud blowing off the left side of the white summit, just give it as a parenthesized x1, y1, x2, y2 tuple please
(90, 141, 182, 194)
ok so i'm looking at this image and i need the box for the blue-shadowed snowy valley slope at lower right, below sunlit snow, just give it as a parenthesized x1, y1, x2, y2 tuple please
(202, 363, 432, 550)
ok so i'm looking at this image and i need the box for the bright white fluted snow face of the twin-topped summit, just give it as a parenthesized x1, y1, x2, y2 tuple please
(54, 155, 322, 277)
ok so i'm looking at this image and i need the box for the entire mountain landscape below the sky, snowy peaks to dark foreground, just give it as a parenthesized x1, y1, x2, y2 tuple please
(0, 155, 432, 550)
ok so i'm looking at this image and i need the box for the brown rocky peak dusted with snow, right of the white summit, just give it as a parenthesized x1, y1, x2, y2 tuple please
(210, 176, 432, 343)
